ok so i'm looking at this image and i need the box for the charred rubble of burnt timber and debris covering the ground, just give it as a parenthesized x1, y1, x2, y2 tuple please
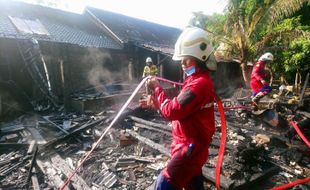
(0, 87, 310, 190)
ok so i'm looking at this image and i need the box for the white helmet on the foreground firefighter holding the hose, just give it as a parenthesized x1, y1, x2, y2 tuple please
(172, 27, 216, 70)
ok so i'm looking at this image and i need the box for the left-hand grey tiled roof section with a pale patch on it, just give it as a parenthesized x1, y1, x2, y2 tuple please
(0, 1, 122, 49)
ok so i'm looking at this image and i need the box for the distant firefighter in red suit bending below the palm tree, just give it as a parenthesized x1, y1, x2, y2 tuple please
(251, 52, 273, 106)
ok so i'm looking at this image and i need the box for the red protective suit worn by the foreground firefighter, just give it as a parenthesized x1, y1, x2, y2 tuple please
(155, 70, 215, 186)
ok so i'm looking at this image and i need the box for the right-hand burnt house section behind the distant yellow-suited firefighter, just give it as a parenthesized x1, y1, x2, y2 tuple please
(84, 7, 182, 81)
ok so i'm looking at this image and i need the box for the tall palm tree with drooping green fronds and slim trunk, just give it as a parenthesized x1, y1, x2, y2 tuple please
(209, 0, 310, 85)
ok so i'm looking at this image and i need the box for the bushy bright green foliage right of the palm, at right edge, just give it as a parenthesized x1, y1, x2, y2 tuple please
(264, 16, 310, 82)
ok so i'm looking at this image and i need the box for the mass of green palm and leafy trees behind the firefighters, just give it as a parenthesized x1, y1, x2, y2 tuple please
(189, 0, 310, 84)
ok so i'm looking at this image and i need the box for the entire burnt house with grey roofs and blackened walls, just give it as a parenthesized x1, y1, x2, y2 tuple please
(0, 1, 181, 115)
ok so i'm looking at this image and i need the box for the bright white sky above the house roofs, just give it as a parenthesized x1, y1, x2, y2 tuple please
(15, 0, 227, 29)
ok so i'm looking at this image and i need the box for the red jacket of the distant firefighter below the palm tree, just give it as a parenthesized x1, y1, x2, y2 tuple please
(250, 61, 266, 93)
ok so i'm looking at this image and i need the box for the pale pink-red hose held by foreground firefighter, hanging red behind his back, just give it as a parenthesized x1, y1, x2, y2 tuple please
(59, 77, 226, 190)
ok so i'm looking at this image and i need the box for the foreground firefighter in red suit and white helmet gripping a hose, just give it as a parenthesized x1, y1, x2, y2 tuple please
(147, 27, 216, 190)
